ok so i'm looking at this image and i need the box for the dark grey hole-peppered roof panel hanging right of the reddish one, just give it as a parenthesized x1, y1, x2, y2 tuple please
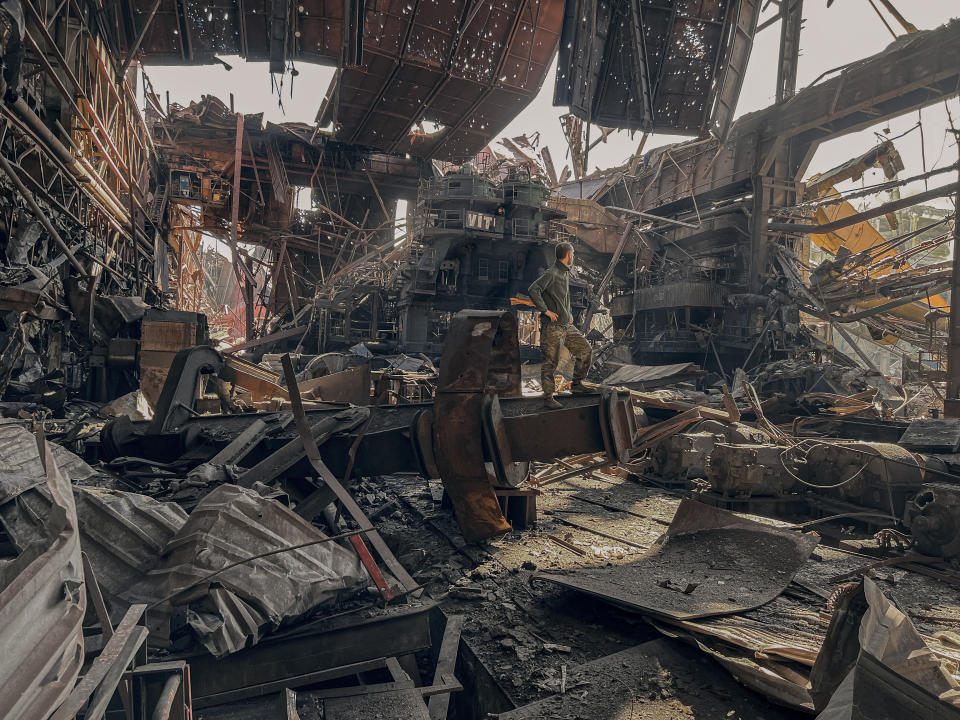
(554, 0, 760, 136)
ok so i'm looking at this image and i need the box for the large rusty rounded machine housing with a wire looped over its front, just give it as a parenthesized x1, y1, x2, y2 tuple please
(795, 442, 924, 518)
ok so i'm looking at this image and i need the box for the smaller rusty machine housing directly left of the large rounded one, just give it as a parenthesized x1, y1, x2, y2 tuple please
(707, 443, 796, 497)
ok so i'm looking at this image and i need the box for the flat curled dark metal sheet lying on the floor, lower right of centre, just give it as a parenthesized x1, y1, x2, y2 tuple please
(537, 499, 819, 620)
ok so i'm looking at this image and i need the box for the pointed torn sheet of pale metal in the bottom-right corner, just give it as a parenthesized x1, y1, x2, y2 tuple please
(817, 578, 960, 720)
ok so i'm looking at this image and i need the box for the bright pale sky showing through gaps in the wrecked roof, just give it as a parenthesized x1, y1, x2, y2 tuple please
(147, 0, 960, 201)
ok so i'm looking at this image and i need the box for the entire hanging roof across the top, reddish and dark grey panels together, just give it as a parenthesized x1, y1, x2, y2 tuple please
(124, 0, 761, 161)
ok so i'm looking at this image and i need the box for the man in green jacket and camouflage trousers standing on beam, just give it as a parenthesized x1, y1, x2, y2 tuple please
(529, 243, 593, 410)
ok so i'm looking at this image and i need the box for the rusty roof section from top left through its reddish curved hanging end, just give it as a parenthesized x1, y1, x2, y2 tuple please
(127, 0, 564, 160)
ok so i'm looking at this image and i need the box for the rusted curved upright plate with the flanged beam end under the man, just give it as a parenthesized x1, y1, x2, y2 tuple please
(433, 310, 636, 542)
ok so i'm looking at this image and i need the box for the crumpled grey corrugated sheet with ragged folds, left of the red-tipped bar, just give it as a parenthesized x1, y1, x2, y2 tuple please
(137, 485, 369, 657)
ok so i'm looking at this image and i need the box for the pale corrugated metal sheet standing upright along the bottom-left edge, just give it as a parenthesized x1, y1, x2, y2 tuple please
(0, 423, 86, 720)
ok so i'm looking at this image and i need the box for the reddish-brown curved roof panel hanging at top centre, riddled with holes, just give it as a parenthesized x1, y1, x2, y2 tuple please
(320, 0, 563, 160)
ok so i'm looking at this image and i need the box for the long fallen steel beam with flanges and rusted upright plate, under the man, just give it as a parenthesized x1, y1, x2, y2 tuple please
(101, 310, 637, 542)
